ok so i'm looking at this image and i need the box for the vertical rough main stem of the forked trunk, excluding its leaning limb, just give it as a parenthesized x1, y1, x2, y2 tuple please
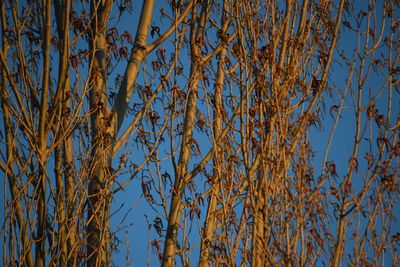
(87, 1, 114, 267)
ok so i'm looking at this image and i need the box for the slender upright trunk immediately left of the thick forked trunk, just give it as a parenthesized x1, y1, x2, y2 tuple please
(53, 0, 76, 266)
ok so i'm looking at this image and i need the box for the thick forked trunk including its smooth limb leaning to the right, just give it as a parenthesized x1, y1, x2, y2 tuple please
(87, 1, 154, 266)
